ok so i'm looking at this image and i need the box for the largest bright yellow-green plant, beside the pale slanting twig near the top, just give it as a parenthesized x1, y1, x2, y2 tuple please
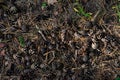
(74, 1, 91, 18)
